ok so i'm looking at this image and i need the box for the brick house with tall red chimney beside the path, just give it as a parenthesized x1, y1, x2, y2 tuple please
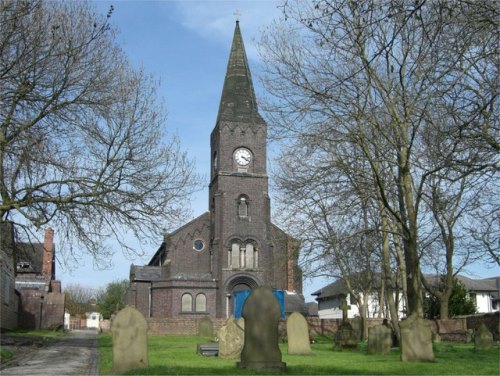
(15, 228, 65, 329)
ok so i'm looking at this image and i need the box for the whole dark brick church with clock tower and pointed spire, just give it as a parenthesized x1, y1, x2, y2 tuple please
(127, 21, 305, 318)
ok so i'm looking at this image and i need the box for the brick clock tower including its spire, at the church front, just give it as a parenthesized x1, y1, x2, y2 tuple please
(209, 21, 277, 315)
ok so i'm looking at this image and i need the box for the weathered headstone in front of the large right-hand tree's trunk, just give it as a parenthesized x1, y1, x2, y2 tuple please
(399, 314, 434, 362)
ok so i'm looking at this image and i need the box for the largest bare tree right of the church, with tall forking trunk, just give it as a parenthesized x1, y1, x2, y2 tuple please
(261, 0, 498, 316)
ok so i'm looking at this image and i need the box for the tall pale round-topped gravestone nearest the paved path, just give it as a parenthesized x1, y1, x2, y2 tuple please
(111, 306, 148, 374)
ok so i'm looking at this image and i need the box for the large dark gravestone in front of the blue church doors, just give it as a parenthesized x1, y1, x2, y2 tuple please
(237, 287, 286, 371)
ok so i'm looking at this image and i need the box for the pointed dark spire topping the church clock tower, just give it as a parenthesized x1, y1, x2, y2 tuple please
(217, 21, 261, 122)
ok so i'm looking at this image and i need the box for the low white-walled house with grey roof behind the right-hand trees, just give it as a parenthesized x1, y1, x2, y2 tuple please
(311, 275, 500, 319)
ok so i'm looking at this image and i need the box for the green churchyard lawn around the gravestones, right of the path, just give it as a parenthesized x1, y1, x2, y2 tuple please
(99, 334, 500, 375)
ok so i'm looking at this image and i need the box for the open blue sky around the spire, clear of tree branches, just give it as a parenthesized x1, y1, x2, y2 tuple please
(55, 0, 500, 301)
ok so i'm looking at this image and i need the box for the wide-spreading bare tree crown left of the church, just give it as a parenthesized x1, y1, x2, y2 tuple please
(0, 0, 197, 261)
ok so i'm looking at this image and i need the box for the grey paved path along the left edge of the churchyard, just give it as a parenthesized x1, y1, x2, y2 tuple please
(0, 330, 99, 376)
